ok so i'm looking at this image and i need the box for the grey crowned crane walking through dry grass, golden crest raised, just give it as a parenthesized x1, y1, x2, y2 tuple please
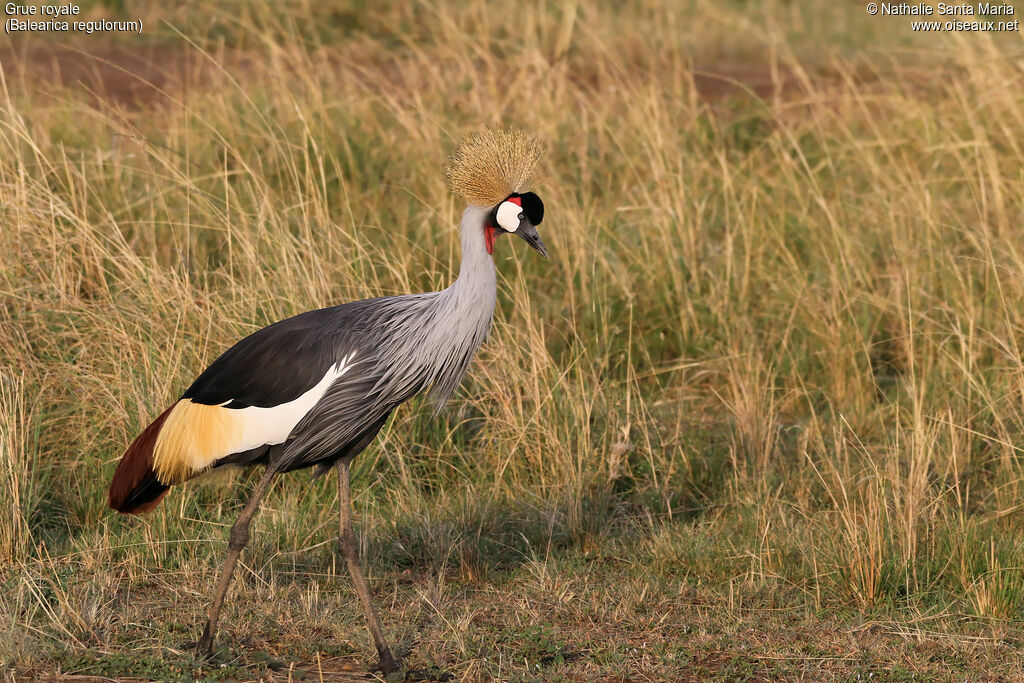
(109, 131, 547, 675)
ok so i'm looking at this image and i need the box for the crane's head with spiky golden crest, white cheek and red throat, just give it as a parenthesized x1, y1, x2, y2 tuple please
(444, 130, 548, 258)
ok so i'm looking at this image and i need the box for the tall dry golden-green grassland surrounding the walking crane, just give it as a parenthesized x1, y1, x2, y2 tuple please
(0, 0, 1024, 680)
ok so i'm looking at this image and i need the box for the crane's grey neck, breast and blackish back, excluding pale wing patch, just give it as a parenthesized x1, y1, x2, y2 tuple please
(192, 207, 497, 479)
